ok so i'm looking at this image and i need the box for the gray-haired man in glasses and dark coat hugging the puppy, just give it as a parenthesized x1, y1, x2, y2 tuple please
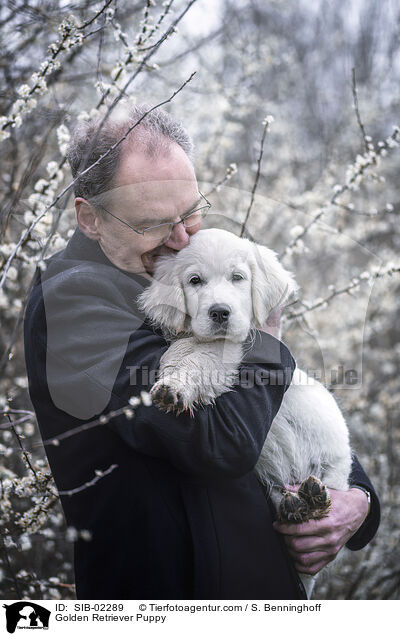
(25, 107, 379, 599)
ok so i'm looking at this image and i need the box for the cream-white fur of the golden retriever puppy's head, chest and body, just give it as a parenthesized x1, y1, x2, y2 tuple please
(140, 229, 351, 596)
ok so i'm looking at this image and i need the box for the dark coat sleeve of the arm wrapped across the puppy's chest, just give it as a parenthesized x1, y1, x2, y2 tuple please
(38, 268, 295, 479)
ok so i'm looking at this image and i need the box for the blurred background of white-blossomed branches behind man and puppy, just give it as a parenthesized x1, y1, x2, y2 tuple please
(0, 0, 400, 599)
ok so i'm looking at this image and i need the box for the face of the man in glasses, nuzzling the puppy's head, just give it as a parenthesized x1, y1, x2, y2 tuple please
(87, 143, 200, 274)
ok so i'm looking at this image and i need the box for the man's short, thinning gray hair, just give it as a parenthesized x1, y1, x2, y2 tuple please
(67, 104, 193, 213)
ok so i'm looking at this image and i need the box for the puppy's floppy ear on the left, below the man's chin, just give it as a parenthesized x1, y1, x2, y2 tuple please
(138, 256, 186, 334)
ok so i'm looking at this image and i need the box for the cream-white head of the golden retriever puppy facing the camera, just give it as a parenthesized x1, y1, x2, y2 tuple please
(140, 229, 297, 342)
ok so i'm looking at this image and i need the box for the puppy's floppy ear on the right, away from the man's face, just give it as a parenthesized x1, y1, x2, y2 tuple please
(250, 244, 298, 327)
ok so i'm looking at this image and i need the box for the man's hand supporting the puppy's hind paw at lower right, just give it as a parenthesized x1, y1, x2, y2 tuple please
(274, 488, 368, 574)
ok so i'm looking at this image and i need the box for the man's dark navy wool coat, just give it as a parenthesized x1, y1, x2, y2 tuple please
(25, 230, 379, 599)
